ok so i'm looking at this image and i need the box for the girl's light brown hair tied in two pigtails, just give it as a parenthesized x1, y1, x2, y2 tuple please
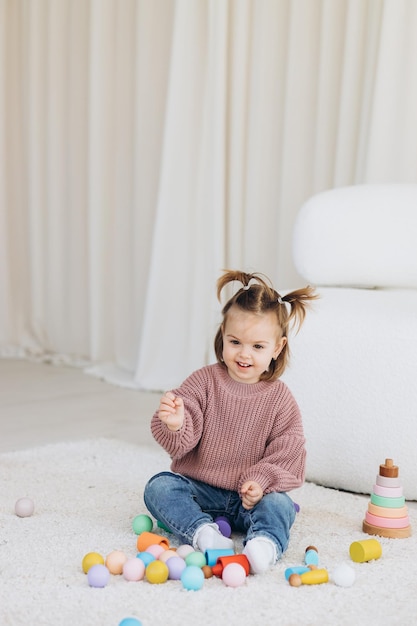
(214, 270, 318, 380)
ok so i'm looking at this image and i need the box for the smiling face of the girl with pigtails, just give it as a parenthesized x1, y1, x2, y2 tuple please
(223, 306, 287, 384)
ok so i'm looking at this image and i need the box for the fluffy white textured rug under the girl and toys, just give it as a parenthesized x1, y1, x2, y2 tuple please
(0, 440, 417, 626)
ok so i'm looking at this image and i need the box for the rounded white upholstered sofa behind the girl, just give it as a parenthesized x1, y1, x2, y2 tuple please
(283, 184, 417, 500)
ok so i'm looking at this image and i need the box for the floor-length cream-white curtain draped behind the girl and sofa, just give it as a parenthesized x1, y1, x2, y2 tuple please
(0, 0, 417, 389)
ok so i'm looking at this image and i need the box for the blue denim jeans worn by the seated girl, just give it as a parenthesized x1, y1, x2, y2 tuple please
(143, 472, 295, 558)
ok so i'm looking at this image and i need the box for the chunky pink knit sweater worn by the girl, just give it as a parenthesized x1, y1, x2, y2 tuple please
(151, 363, 306, 493)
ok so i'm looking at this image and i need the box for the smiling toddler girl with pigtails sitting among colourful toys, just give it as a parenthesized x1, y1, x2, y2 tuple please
(144, 271, 317, 574)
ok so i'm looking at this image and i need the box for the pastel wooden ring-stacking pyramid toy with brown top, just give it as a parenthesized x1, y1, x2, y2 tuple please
(362, 459, 411, 539)
